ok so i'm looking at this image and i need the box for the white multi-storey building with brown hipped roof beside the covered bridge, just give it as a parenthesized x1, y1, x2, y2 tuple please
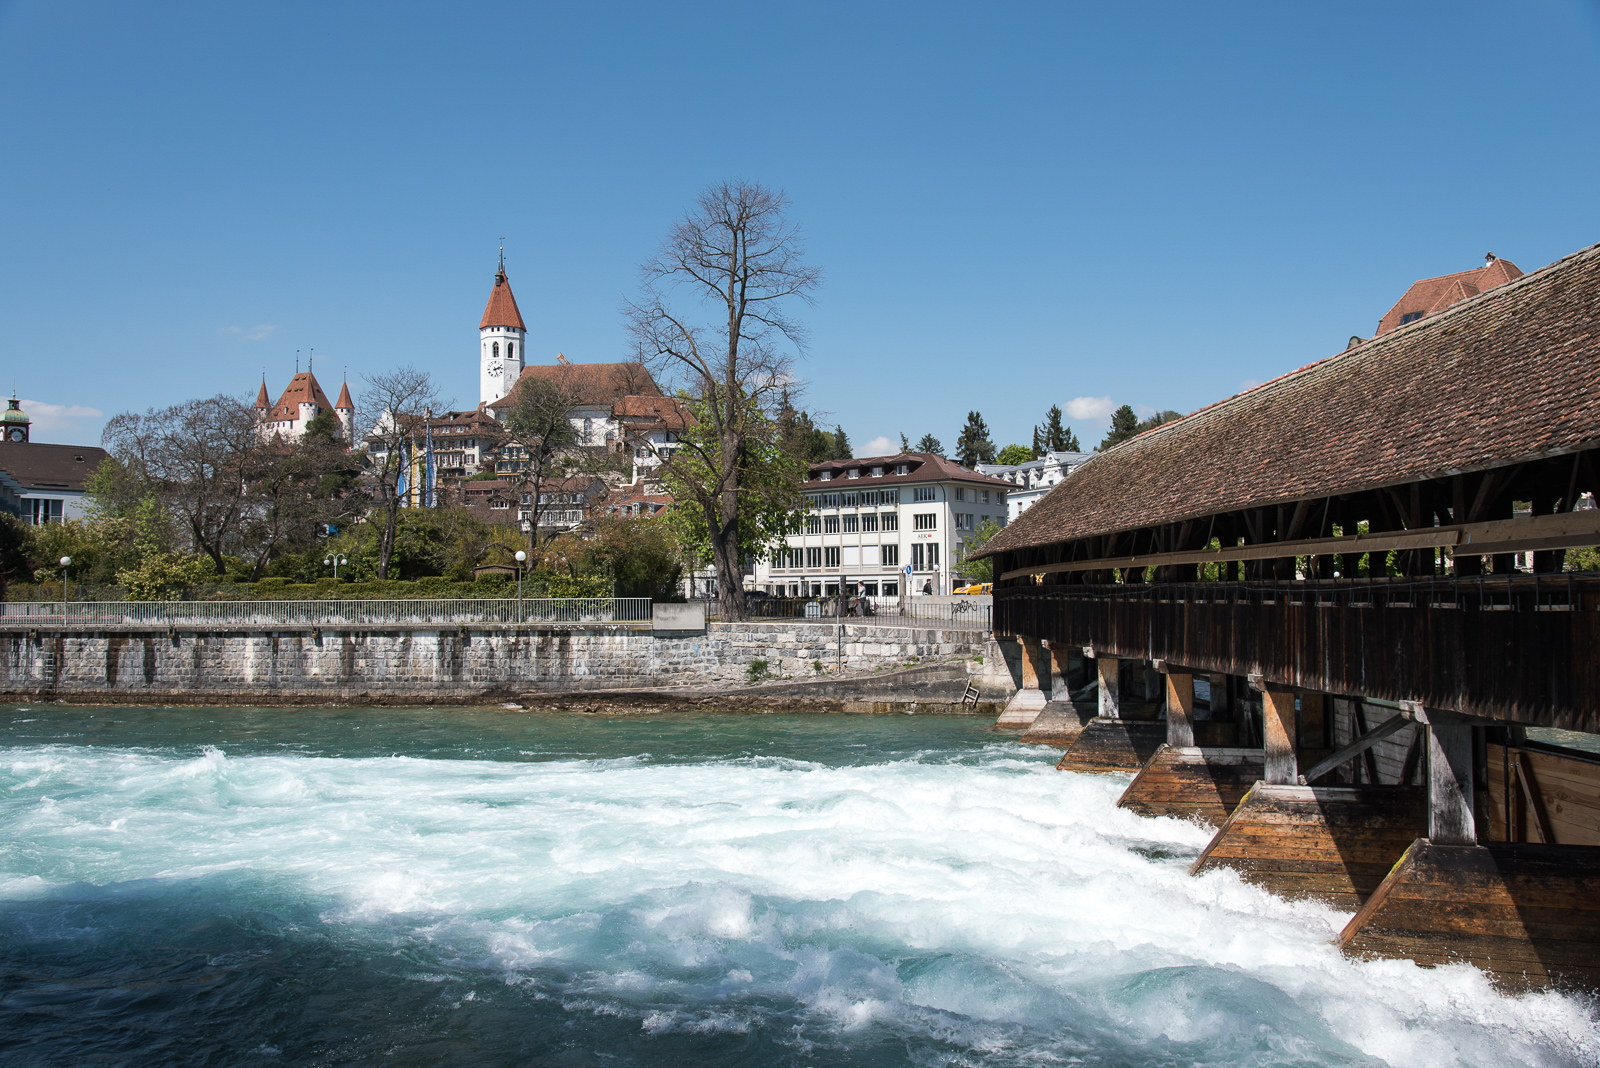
(746, 452, 1013, 596)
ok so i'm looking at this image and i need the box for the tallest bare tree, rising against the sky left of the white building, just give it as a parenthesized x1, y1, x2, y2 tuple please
(626, 181, 822, 619)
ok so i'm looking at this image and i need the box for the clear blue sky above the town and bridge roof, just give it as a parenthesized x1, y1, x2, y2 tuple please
(0, 0, 1600, 452)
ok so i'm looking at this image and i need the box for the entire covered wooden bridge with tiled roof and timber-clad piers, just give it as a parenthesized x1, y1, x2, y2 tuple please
(986, 238, 1600, 990)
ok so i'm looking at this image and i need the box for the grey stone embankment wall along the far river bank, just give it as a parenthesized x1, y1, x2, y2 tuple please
(0, 620, 1014, 703)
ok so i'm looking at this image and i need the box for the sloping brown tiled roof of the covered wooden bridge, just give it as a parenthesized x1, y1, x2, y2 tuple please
(984, 245, 1600, 555)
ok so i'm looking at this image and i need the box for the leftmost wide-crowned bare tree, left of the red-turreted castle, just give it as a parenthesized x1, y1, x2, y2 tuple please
(102, 395, 262, 574)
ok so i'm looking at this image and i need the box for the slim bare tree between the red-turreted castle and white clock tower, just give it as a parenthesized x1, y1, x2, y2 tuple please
(357, 365, 443, 579)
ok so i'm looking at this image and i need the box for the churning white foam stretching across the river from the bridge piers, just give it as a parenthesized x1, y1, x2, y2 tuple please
(0, 745, 1600, 1066)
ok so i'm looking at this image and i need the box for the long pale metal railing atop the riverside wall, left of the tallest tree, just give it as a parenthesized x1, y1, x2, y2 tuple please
(0, 596, 650, 627)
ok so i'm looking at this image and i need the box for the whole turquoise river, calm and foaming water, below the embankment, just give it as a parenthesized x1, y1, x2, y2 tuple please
(0, 705, 1600, 1068)
